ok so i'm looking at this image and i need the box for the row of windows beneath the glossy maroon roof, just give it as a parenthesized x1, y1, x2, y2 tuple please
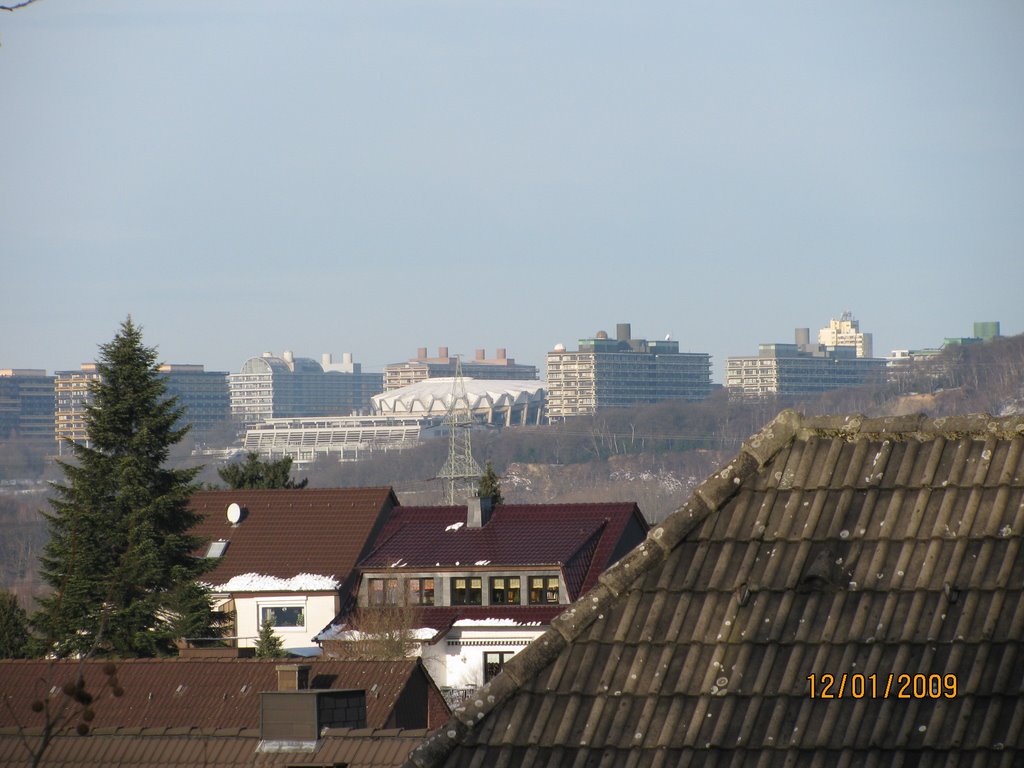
(369, 577, 558, 605)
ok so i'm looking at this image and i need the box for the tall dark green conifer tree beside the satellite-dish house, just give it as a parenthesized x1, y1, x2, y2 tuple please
(34, 317, 218, 656)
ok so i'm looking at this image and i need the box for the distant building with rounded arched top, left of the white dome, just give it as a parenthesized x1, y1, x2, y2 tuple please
(227, 351, 383, 425)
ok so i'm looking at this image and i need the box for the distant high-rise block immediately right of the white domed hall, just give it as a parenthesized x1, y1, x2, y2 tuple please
(547, 323, 712, 421)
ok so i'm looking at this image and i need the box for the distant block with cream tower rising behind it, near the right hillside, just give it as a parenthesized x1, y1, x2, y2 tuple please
(725, 312, 888, 398)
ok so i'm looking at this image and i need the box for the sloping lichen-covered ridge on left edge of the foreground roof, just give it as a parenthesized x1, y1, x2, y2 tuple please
(406, 409, 804, 768)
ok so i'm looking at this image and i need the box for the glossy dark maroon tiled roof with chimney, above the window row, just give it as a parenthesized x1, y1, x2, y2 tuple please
(359, 502, 646, 597)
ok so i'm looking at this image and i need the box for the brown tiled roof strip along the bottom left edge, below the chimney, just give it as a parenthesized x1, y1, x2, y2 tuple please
(0, 728, 426, 768)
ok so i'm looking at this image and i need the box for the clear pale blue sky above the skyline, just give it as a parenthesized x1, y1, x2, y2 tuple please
(0, 0, 1024, 381)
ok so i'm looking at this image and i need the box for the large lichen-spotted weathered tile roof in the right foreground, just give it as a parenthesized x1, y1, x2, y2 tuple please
(409, 412, 1024, 768)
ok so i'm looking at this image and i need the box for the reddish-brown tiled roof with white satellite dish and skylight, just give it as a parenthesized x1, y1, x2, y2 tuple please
(191, 487, 397, 586)
